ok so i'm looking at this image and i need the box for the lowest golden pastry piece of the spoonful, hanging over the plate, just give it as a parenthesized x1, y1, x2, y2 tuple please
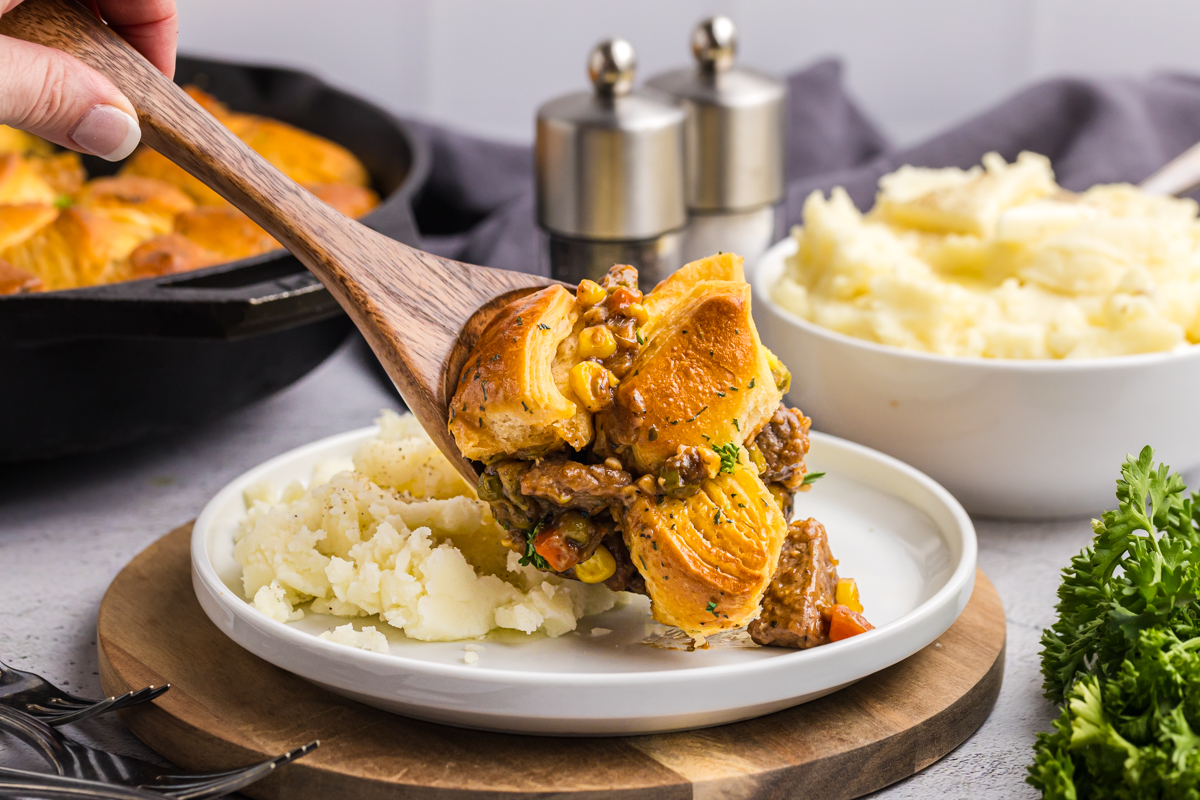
(624, 463, 787, 642)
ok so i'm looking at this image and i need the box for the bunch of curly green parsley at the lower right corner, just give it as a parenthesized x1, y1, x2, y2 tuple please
(1027, 447, 1200, 800)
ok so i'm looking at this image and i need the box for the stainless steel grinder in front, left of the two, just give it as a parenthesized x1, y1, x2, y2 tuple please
(535, 38, 688, 291)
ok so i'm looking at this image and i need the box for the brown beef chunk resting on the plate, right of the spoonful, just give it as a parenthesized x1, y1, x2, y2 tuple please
(749, 518, 838, 649)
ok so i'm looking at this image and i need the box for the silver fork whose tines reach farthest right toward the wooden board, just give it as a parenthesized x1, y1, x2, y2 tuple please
(0, 705, 320, 800)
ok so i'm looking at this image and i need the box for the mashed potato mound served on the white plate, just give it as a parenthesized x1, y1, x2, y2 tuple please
(234, 411, 617, 652)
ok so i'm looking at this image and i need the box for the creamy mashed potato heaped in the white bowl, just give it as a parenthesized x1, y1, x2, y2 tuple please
(772, 152, 1200, 359)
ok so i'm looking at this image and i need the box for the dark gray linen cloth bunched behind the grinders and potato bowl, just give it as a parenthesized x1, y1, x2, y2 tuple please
(405, 60, 1200, 272)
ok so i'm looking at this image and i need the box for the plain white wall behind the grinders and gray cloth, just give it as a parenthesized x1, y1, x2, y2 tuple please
(178, 0, 1200, 148)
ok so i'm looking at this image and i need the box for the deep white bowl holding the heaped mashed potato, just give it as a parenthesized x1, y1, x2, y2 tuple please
(750, 237, 1200, 518)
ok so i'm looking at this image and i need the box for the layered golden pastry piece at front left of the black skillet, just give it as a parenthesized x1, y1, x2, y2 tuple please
(0, 207, 146, 291)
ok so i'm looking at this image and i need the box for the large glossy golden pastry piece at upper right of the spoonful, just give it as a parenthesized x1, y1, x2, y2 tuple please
(596, 281, 784, 473)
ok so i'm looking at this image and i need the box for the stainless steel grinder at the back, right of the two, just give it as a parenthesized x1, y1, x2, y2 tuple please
(646, 17, 787, 265)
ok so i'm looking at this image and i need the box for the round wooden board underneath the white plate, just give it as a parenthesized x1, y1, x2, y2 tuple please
(97, 525, 1004, 800)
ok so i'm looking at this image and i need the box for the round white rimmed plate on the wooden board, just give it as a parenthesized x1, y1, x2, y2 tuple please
(192, 428, 976, 735)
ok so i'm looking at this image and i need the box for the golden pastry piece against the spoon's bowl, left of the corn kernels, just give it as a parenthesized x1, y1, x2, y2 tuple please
(450, 285, 592, 463)
